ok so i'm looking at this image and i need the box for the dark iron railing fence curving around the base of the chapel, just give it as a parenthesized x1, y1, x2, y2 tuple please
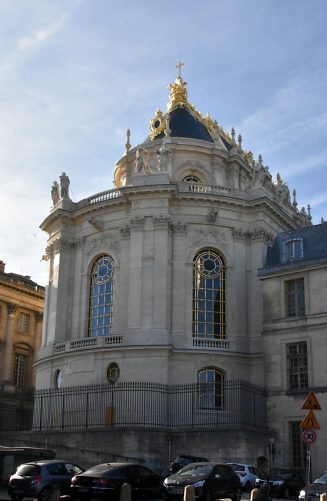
(33, 380, 266, 430)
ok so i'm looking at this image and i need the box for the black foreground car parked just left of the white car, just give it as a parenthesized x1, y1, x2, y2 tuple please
(163, 462, 242, 501)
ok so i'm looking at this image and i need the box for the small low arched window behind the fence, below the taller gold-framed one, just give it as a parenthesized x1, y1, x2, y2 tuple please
(198, 367, 225, 409)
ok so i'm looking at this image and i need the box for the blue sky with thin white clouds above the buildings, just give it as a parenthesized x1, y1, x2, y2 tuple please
(0, 0, 327, 285)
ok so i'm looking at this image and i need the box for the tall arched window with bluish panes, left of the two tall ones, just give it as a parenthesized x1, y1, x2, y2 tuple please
(89, 256, 114, 337)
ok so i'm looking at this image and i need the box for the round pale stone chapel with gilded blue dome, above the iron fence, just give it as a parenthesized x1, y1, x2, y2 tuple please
(35, 73, 326, 472)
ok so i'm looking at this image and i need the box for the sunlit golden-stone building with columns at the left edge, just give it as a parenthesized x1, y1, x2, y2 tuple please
(0, 261, 45, 430)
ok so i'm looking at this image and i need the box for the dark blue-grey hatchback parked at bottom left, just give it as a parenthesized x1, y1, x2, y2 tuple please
(8, 459, 83, 501)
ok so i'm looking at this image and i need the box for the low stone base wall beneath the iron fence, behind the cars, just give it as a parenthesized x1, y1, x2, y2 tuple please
(0, 428, 269, 474)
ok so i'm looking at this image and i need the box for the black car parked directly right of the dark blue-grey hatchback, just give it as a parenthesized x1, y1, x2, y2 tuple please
(71, 463, 163, 500)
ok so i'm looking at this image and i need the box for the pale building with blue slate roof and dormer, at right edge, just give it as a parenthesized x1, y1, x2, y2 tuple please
(259, 223, 327, 469)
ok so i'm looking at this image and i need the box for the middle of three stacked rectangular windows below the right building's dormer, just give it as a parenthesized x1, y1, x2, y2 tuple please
(286, 341, 308, 390)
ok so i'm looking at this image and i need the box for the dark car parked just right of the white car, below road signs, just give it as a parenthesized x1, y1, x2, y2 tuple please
(255, 468, 305, 499)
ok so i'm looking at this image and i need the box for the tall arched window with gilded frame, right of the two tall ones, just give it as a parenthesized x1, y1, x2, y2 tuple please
(193, 249, 226, 339)
